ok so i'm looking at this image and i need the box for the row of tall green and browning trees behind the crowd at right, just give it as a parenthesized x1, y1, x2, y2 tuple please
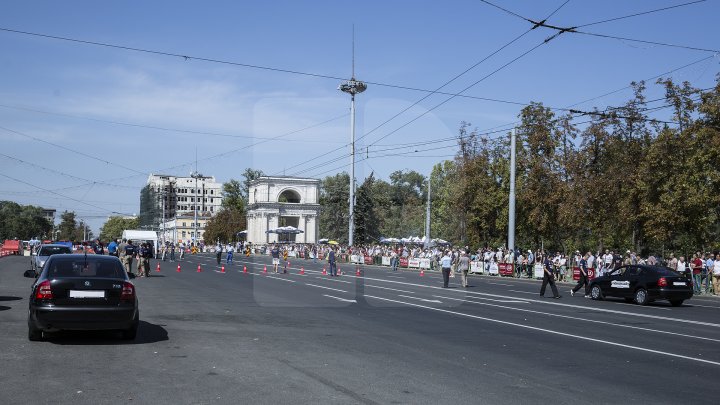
(320, 75, 720, 254)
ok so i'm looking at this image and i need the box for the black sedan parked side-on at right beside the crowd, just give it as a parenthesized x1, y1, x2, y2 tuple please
(590, 265, 693, 307)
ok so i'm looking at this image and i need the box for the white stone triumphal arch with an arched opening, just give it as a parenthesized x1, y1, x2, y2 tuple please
(247, 176, 320, 244)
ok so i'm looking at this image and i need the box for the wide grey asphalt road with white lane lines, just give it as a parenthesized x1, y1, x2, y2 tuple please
(0, 254, 720, 404)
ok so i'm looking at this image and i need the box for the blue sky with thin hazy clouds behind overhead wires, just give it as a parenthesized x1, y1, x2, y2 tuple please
(0, 0, 720, 233)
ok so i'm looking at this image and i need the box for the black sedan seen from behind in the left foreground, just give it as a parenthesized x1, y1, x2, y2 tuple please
(25, 254, 140, 340)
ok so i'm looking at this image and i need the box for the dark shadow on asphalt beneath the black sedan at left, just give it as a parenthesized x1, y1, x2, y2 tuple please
(45, 321, 168, 346)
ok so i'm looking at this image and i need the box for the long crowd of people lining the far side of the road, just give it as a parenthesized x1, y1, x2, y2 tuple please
(69, 240, 720, 296)
